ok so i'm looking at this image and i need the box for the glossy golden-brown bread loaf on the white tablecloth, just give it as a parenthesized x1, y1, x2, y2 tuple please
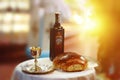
(53, 52, 87, 72)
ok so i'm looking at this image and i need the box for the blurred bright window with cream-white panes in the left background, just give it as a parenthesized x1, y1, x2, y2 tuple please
(0, 0, 30, 43)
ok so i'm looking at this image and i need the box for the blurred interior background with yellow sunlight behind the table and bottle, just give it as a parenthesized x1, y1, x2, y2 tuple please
(0, 0, 120, 80)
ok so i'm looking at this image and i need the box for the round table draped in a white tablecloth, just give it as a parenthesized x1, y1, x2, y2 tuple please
(11, 58, 96, 80)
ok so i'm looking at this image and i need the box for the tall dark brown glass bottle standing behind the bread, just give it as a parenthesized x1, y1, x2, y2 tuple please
(50, 13, 64, 61)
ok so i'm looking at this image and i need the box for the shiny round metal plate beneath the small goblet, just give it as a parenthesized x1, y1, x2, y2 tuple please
(22, 61, 54, 74)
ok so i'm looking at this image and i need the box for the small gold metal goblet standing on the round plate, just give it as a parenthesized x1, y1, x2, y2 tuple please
(30, 47, 41, 72)
